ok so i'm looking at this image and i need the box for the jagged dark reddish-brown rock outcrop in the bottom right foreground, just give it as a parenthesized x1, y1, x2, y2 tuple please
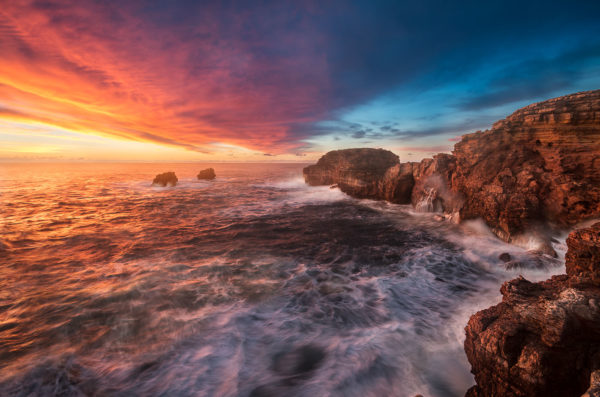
(465, 223, 600, 397)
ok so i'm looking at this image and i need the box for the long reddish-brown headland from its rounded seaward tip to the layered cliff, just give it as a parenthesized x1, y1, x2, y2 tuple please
(304, 90, 600, 244)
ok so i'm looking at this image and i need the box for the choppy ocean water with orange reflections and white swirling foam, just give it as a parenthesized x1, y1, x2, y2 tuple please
(0, 163, 564, 397)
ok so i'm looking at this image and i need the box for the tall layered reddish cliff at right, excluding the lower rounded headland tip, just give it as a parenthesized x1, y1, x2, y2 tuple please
(451, 91, 600, 241)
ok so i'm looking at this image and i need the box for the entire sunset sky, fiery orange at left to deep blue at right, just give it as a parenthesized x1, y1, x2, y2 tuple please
(0, 0, 600, 162)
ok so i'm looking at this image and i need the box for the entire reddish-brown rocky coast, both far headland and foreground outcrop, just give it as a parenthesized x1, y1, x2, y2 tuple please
(304, 90, 600, 397)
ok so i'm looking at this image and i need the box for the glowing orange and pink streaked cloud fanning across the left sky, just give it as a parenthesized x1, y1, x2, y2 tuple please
(0, 0, 328, 158)
